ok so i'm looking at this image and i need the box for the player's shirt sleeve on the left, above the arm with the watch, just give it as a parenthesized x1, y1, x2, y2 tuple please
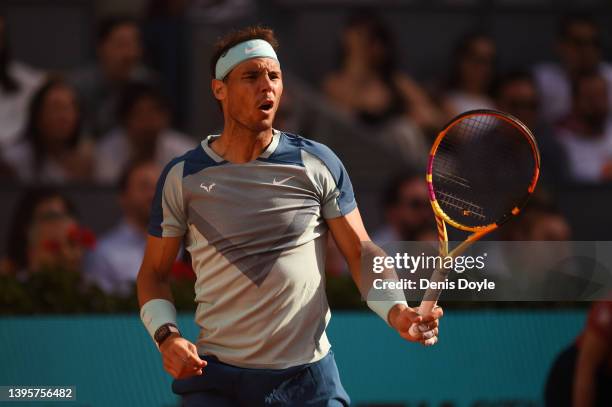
(149, 160, 187, 237)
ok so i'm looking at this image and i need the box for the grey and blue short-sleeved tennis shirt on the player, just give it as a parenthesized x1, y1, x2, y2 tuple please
(149, 131, 357, 369)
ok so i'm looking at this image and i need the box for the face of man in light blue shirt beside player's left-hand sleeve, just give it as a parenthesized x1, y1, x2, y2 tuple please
(121, 163, 160, 226)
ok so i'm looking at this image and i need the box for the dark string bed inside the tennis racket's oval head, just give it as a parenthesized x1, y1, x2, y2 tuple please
(432, 114, 535, 227)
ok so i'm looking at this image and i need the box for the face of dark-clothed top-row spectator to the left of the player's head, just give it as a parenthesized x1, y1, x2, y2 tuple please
(98, 23, 142, 81)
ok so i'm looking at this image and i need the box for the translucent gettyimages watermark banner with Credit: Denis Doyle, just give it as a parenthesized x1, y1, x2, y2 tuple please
(360, 241, 612, 301)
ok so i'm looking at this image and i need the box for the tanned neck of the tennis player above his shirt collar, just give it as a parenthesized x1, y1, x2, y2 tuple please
(211, 122, 272, 164)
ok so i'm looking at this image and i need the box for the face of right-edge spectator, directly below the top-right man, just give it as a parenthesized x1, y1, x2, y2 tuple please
(574, 76, 609, 130)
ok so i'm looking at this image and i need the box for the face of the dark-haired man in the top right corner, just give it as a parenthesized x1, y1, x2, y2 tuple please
(559, 22, 601, 74)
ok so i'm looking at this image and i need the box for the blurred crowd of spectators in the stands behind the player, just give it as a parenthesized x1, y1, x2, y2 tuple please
(0, 2, 612, 308)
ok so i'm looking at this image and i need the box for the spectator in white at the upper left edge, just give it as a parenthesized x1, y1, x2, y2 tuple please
(0, 14, 44, 150)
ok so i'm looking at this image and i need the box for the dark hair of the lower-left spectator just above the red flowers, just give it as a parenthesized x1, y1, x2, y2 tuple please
(6, 186, 76, 270)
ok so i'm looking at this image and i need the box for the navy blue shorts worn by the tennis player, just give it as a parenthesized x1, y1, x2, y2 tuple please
(172, 351, 350, 407)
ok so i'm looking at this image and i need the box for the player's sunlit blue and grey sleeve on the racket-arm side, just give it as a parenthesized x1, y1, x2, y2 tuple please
(302, 141, 357, 219)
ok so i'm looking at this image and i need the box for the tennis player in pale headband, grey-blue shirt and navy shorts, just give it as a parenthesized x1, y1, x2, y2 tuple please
(138, 27, 442, 406)
